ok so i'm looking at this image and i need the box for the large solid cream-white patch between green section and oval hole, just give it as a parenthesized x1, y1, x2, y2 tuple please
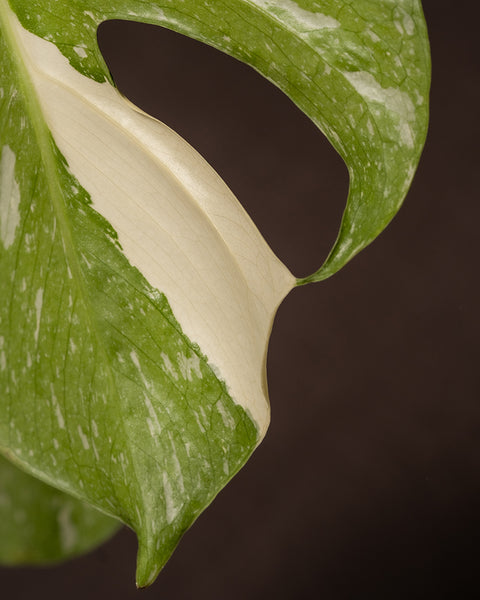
(7, 8, 295, 436)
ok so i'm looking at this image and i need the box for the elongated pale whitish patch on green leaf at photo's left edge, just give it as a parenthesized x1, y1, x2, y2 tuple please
(0, 145, 20, 249)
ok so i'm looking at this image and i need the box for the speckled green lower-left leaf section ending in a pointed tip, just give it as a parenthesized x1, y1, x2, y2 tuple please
(0, 4, 258, 585)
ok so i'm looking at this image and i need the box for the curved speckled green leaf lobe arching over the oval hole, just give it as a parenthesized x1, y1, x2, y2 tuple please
(13, 0, 430, 284)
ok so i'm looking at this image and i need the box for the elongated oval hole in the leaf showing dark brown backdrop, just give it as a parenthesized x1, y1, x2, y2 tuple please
(98, 21, 348, 277)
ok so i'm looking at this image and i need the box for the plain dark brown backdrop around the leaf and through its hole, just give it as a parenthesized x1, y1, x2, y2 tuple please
(0, 0, 480, 600)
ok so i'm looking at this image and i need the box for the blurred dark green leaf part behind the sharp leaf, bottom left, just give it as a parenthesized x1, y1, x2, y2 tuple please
(0, 458, 120, 565)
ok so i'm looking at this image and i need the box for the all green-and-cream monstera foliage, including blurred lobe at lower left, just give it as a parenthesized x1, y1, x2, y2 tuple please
(0, 0, 429, 586)
